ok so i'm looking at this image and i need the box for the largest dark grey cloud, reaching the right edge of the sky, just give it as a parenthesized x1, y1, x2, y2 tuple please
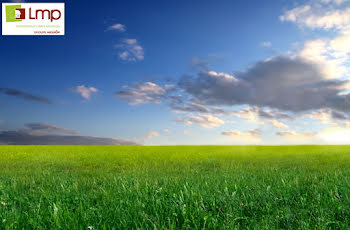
(179, 56, 350, 112)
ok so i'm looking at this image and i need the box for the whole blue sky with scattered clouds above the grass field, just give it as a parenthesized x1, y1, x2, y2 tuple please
(0, 0, 350, 145)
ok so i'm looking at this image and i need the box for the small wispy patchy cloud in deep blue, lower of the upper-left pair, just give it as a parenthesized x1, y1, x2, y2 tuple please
(116, 38, 144, 62)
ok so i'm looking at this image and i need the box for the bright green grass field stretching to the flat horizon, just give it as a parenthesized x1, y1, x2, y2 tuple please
(0, 146, 350, 229)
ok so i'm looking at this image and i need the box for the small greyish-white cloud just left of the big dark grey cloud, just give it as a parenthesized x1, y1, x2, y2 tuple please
(116, 82, 174, 105)
